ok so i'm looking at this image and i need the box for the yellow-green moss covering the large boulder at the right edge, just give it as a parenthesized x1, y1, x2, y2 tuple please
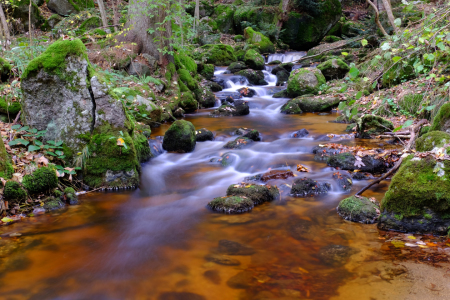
(381, 155, 450, 217)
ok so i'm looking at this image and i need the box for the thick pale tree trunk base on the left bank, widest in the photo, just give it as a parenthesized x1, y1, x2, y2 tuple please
(118, 0, 173, 65)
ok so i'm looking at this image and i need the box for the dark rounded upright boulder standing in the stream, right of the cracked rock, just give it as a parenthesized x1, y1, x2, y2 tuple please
(163, 120, 196, 153)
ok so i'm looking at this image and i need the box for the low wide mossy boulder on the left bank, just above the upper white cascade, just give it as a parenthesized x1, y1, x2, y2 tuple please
(193, 44, 237, 66)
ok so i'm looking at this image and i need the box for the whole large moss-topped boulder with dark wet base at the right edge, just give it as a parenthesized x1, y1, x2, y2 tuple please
(378, 155, 450, 235)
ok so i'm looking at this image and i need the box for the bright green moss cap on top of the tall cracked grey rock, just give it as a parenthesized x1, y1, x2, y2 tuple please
(22, 39, 89, 80)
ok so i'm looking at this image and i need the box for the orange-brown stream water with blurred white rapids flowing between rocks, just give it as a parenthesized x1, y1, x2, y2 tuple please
(0, 54, 446, 300)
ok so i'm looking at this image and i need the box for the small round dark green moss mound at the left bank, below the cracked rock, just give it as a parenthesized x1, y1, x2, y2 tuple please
(22, 167, 58, 194)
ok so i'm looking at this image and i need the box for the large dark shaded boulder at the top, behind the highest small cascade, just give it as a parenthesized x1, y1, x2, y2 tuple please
(280, 0, 342, 50)
